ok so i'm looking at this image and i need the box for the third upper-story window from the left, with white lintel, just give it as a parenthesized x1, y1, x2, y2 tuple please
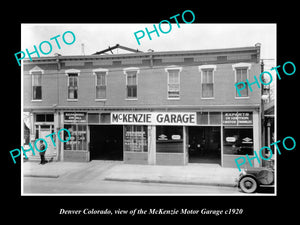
(93, 69, 108, 100)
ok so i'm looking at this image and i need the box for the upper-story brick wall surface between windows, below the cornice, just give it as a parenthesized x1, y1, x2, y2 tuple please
(24, 64, 260, 107)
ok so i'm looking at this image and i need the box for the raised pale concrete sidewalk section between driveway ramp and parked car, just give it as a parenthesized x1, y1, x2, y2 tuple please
(105, 164, 239, 187)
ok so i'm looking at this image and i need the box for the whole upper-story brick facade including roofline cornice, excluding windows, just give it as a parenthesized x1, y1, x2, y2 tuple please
(23, 47, 260, 108)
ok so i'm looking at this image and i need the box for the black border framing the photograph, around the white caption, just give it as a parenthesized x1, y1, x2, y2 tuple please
(2, 2, 298, 222)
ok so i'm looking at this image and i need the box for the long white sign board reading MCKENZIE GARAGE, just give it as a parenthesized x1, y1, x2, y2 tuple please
(111, 112, 197, 125)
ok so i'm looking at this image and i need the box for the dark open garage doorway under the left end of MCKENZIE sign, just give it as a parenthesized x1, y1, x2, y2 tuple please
(89, 125, 123, 160)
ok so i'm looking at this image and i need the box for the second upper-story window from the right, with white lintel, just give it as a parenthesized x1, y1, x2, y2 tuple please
(199, 65, 217, 98)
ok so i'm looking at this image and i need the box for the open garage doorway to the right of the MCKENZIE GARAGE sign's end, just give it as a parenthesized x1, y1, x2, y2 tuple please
(188, 127, 221, 165)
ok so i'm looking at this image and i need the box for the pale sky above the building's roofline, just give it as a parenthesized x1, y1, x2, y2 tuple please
(21, 23, 276, 66)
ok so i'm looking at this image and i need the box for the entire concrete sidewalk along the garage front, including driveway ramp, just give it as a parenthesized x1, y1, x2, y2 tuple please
(23, 161, 239, 187)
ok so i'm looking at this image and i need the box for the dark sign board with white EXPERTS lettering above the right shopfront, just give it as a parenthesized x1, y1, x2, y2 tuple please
(223, 112, 253, 126)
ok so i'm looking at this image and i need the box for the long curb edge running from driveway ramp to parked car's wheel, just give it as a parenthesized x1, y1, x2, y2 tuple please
(104, 177, 237, 187)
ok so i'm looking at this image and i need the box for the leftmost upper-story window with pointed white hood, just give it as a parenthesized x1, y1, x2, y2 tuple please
(29, 67, 44, 100)
